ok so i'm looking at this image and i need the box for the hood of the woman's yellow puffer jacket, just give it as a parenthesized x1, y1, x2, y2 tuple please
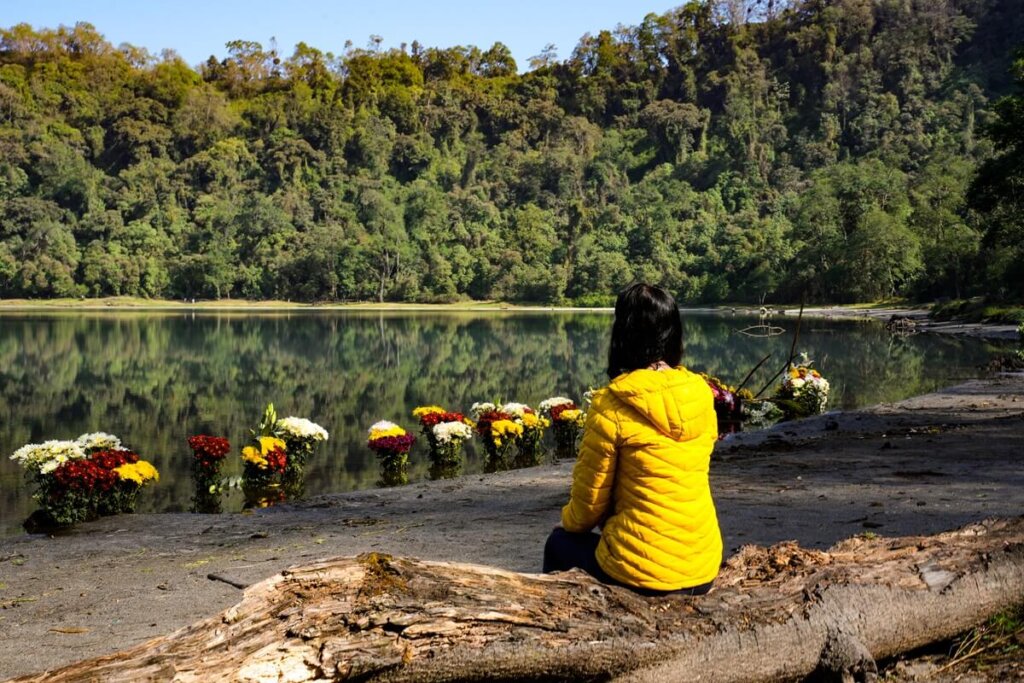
(608, 367, 714, 441)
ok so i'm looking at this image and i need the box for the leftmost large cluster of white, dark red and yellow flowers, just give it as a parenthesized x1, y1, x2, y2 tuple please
(11, 432, 160, 526)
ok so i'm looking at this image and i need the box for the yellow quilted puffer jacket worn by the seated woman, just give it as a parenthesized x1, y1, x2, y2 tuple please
(562, 368, 722, 591)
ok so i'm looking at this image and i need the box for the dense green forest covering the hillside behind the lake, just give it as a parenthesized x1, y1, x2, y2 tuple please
(0, 0, 1024, 303)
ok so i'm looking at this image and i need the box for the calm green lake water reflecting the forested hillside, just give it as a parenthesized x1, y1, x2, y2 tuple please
(0, 310, 995, 535)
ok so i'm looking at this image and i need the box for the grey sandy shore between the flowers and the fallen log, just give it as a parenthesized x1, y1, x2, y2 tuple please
(0, 375, 1024, 679)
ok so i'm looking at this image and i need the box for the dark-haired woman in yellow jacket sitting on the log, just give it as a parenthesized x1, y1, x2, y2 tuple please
(544, 284, 722, 595)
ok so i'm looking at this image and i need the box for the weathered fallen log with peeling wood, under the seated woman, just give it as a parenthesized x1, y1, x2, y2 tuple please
(17, 517, 1024, 683)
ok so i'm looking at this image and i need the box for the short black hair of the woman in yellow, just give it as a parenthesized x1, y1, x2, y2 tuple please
(607, 283, 683, 379)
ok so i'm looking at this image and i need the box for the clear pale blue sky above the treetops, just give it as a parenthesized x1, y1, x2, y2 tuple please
(0, 0, 684, 71)
